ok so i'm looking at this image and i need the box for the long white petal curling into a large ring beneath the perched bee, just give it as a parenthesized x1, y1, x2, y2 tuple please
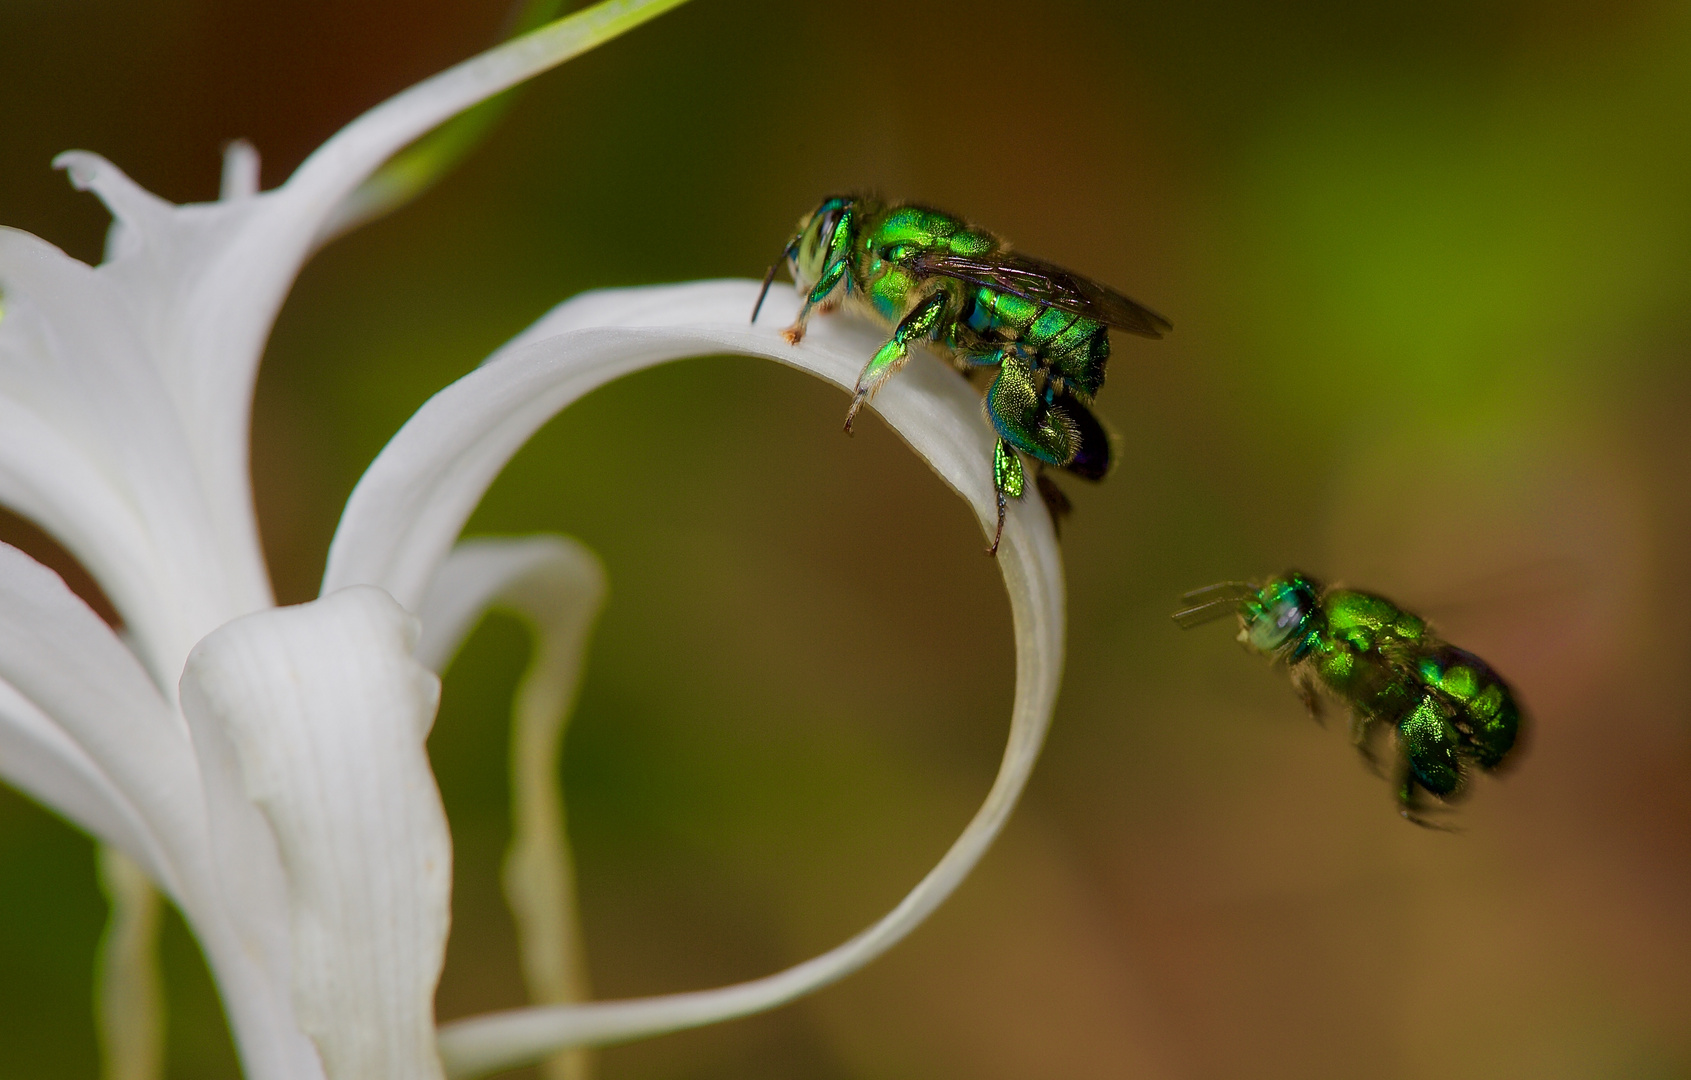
(325, 281, 1064, 1077)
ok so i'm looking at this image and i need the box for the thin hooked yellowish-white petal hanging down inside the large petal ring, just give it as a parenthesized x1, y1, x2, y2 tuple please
(418, 536, 605, 1080)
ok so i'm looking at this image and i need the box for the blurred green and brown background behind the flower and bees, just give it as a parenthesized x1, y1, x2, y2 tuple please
(0, 0, 1691, 1080)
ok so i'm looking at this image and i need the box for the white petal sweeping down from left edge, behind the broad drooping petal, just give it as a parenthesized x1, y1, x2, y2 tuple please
(0, 544, 316, 1080)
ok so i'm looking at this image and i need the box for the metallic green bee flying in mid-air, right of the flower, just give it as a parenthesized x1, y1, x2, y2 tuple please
(1174, 571, 1522, 825)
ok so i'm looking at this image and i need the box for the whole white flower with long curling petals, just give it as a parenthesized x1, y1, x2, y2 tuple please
(0, 0, 1064, 1080)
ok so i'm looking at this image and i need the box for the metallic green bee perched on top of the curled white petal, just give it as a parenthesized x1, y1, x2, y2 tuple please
(751, 196, 1172, 554)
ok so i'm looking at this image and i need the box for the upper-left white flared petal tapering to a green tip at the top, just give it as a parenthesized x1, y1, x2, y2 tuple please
(0, 0, 681, 679)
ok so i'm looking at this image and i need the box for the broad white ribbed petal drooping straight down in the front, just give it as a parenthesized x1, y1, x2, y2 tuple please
(181, 588, 451, 1080)
